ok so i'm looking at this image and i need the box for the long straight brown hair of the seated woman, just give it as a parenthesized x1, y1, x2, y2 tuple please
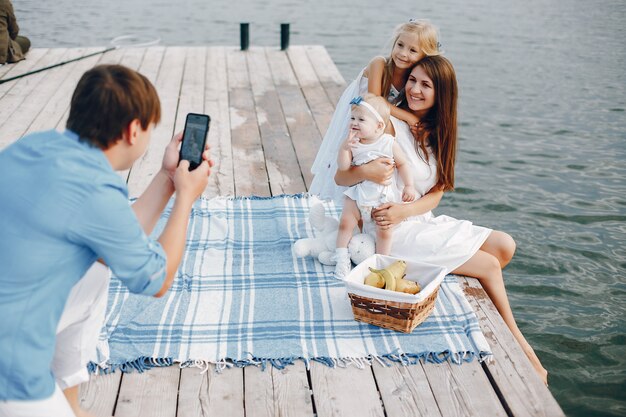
(403, 56, 458, 191)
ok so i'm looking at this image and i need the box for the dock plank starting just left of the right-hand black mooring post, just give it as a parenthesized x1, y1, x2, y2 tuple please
(266, 48, 322, 189)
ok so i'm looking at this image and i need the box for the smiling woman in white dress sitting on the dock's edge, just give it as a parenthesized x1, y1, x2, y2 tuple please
(335, 56, 547, 383)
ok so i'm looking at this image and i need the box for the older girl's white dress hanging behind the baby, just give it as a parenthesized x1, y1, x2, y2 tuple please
(309, 70, 400, 207)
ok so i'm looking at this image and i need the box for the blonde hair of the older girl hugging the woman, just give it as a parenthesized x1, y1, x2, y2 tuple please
(381, 19, 442, 101)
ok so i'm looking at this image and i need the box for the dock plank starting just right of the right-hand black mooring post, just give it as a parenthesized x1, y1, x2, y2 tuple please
(287, 46, 335, 137)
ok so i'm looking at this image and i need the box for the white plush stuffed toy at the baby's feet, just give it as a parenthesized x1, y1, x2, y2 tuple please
(293, 203, 376, 265)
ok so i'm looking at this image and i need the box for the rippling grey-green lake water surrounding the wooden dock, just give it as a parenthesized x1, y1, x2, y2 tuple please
(14, 0, 626, 416)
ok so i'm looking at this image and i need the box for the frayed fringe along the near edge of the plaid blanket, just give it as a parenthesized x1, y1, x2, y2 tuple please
(87, 351, 493, 375)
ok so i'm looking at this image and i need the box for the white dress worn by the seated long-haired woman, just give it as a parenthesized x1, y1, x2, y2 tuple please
(352, 117, 491, 272)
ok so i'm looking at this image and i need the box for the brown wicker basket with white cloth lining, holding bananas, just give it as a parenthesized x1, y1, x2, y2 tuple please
(346, 255, 446, 333)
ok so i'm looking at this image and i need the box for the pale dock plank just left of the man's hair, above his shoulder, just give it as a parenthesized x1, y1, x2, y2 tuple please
(0, 48, 98, 148)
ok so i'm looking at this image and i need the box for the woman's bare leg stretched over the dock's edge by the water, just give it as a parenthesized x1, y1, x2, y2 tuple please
(453, 250, 548, 385)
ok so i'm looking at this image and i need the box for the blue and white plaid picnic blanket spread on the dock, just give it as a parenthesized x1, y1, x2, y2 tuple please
(90, 195, 490, 371)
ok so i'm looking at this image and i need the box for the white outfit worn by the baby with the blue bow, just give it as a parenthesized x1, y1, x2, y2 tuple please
(344, 133, 401, 211)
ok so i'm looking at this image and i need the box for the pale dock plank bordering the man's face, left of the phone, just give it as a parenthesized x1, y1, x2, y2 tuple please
(128, 47, 185, 197)
